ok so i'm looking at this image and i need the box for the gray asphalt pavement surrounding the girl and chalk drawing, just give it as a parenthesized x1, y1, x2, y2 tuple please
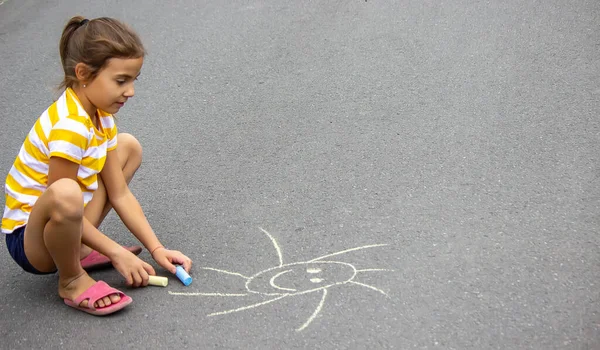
(0, 0, 600, 349)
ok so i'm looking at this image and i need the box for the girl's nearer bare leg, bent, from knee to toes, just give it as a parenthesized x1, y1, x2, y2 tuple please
(24, 179, 120, 307)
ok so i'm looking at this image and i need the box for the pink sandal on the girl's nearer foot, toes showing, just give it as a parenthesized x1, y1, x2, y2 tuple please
(64, 281, 133, 316)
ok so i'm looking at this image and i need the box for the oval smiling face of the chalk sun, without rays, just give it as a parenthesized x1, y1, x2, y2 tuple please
(246, 261, 356, 295)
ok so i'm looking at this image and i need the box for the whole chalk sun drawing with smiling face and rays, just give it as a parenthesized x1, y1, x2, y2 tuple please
(169, 228, 393, 332)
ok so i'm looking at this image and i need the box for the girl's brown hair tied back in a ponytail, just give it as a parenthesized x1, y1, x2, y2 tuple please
(59, 16, 146, 89)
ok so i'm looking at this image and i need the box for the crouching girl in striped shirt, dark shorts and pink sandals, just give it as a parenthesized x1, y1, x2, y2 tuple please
(2, 16, 192, 315)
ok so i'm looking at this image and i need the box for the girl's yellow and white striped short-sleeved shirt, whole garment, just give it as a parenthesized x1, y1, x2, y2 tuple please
(2, 88, 117, 233)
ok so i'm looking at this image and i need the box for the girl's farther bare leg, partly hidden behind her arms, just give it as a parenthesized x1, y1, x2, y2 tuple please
(80, 133, 142, 259)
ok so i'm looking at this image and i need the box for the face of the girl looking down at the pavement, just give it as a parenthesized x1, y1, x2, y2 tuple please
(83, 57, 144, 114)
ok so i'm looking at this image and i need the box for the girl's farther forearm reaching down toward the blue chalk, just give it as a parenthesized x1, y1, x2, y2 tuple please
(110, 191, 162, 252)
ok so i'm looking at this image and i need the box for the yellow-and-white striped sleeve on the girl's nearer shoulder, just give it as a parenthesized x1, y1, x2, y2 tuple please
(48, 118, 89, 164)
